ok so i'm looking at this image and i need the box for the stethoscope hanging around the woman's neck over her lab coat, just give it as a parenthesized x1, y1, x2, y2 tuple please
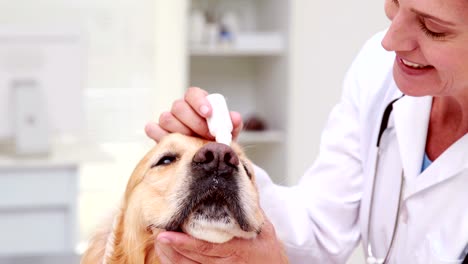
(366, 94, 468, 264)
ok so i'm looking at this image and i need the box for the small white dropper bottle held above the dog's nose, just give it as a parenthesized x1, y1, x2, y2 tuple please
(206, 93, 233, 146)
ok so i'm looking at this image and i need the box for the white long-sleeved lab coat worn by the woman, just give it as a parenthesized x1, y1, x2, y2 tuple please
(256, 29, 468, 264)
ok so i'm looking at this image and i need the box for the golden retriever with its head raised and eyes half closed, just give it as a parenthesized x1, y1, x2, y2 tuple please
(81, 133, 264, 264)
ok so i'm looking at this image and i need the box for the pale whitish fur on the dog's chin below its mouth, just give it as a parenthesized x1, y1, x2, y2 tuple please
(182, 217, 257, 243)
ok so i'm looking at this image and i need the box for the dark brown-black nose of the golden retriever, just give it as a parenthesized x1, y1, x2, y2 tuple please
(192, 142, 239, 173)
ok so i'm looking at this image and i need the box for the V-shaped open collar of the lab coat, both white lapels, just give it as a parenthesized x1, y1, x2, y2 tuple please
(393, 96, 468, 199)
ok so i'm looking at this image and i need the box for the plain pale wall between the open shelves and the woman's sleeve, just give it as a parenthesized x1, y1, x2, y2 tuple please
(288, 0, 388, 184)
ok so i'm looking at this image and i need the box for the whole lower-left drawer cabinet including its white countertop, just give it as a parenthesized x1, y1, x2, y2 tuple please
(0, 140, 111, 256)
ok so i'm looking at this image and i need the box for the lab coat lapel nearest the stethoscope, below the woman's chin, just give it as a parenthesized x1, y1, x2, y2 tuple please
(393, 96, 432, 185)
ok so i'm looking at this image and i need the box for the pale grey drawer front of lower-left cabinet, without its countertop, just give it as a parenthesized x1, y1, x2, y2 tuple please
(0, 166, 78, 256)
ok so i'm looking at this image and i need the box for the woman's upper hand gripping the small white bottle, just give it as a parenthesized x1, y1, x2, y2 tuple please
(145, 87, 242, 142)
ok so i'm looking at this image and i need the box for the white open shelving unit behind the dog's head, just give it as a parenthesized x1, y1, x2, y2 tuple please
(187, 0, 289, 184)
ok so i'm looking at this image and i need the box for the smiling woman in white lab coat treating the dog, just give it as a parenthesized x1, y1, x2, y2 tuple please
(146, 0, 468, 264)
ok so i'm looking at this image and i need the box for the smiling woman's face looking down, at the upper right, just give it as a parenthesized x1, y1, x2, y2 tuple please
(382, 0, 468, 96)
